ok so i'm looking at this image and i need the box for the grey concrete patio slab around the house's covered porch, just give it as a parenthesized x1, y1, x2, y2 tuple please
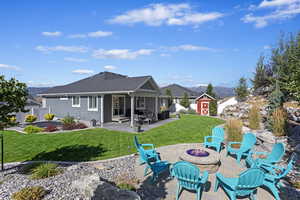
(102, 118, 178, 133)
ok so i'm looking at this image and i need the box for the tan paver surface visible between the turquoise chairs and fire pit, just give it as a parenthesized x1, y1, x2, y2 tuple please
(135, 143, 274, 200)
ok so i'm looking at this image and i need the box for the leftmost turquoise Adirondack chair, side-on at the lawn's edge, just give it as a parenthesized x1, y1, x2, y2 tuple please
(134, 136, 160, 164)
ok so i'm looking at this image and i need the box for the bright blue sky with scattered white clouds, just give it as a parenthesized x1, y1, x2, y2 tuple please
(0, 0, 300, 86)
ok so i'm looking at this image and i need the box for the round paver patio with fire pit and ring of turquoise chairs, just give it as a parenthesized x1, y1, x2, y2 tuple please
(135, 129, 295, 200)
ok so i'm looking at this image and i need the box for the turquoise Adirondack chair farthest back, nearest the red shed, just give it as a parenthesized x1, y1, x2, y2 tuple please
(204, 127, 224, 152)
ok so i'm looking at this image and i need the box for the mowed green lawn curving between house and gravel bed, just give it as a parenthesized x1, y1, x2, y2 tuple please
(4, 115, 223, 162)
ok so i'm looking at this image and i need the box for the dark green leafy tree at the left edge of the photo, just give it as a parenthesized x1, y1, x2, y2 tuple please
(0, 76, 28, 170)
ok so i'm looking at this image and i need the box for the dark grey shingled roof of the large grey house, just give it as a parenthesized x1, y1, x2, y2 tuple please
(40, 72, 159, 95)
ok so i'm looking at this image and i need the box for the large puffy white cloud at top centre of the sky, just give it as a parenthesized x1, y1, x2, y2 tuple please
(109, 3, 224, 26)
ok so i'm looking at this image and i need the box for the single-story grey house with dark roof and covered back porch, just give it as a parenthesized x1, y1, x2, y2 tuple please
(40, 72, 160, 126)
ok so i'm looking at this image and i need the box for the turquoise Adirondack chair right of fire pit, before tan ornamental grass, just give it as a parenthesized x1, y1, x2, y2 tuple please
(227, 133, 256, 163)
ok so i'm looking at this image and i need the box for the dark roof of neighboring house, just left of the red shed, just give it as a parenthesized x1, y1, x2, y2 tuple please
(160, 84, 201, 98)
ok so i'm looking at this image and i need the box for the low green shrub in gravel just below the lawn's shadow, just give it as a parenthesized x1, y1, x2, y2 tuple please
(31, 163, 61, 179)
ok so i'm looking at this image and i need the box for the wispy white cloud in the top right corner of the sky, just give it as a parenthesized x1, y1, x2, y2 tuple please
(241, 0, 300, 28)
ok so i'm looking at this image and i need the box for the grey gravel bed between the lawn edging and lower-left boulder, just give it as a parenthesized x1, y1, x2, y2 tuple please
(0, 156, 136, 200)
